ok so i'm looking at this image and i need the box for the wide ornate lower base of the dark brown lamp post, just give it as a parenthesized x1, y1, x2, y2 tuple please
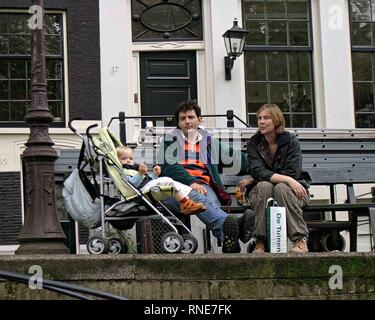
(16, 148, 69, 254)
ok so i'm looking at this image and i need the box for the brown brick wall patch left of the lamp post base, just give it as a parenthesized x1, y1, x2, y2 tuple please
(0, 172, 22, 245)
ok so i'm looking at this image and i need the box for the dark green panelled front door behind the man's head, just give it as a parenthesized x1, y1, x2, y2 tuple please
(140, 51, 197, 126)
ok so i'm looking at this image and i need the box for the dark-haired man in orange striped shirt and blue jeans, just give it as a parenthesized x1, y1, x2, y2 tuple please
(158, 101, 248, 253)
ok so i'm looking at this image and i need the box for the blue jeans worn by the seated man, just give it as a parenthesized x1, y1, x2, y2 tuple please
(163, 184, 227, 240)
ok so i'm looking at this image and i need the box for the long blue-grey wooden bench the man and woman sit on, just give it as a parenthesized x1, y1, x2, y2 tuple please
(55, 128, 375, 251)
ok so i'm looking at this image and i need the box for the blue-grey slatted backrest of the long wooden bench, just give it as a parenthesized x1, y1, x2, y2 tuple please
(55, 128, 375, 185)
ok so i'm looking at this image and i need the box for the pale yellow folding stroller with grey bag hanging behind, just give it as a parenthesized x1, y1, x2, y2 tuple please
(63, 119, 198, 254)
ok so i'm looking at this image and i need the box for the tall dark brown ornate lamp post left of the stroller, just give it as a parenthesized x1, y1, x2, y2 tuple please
(16, 0, 68, 254)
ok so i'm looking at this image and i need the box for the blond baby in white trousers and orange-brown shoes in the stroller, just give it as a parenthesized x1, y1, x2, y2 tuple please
(116, 146, 207, 215)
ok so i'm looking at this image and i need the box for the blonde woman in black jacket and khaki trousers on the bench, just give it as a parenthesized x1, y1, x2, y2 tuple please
(240, 104, 310, 253)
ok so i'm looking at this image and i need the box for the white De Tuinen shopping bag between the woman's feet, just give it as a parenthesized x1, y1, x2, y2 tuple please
(266, 198, 288, 253)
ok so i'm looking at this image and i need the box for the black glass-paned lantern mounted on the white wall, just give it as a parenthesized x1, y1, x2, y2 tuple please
(223, 19, 249, 80)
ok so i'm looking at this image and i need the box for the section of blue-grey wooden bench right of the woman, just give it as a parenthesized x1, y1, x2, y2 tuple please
(300, 130, 375, 251)
